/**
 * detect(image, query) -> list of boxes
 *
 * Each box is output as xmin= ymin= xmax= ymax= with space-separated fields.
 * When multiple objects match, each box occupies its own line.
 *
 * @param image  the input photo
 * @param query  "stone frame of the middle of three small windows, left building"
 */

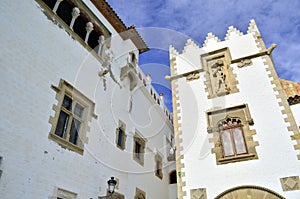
xmin=133 ymin=131 xmax=146 ymax=166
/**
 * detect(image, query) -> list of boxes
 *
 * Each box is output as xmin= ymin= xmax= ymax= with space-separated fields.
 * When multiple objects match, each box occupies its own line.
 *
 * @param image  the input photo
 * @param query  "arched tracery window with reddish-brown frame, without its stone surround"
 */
xmin=219 ymin=118 xmax=247 ymax=157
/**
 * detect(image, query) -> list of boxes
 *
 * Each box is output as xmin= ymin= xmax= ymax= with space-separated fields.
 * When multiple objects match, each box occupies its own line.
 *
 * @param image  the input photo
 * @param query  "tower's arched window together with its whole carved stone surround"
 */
xmin=207 ymin=104 xmax=258 ymax=165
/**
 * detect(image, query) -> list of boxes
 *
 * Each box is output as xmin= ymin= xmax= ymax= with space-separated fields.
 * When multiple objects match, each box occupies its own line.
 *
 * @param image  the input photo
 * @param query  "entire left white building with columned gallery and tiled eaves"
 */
xmin=0 ymin=0 xmax=177 ymax=199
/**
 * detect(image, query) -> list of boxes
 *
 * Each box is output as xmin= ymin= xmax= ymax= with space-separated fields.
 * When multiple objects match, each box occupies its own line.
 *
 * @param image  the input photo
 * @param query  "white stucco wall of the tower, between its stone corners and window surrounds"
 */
xmin=171 ymin=27 xmax=300 ymax=199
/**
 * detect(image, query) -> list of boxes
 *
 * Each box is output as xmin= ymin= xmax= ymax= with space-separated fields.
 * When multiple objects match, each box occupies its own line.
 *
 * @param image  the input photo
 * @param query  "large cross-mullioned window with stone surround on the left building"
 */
xmin=49 ymin=80 xmax=96 ymax=154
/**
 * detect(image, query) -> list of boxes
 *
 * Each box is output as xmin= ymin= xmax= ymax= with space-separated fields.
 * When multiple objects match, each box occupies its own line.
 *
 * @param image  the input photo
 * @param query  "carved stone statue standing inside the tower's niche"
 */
xmin=211 ymin=59 xmax=230 ymax=96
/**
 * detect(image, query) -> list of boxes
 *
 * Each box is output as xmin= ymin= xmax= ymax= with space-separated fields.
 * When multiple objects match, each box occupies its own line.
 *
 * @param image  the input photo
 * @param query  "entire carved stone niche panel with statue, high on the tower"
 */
xmin=201 ymin=48 xmax=239 ymax=99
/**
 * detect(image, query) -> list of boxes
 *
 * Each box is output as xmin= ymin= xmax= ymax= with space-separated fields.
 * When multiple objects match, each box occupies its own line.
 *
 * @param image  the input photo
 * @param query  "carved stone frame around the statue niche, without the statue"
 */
xmin=200 ymin=47 xmax=239 ymax=99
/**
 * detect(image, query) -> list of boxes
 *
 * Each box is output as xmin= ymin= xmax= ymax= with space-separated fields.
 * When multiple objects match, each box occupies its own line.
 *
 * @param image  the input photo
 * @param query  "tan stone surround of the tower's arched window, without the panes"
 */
xmin=206 ymin=104 xmax=259 ymax=165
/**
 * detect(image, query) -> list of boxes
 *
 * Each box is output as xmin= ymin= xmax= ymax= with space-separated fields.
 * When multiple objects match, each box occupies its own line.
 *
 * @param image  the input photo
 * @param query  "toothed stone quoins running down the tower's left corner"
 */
xmin=169 ymin=46 xmax=186 ymax=199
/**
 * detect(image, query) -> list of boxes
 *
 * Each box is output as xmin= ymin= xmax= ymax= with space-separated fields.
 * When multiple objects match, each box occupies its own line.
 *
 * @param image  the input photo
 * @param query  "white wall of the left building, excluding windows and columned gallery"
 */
xmin=0 ymin=0 xmax=176 ymax=199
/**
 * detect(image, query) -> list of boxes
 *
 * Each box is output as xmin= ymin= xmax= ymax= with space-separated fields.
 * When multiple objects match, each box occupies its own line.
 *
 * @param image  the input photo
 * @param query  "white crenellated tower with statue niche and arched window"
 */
xmin=167 ymin=20 xmax=300 ymax=199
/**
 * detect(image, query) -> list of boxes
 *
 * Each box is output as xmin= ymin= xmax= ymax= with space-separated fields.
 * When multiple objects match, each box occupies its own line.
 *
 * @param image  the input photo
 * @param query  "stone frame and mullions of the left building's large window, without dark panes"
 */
xmin=48 ymin=79 xmax=97 ymax=155
